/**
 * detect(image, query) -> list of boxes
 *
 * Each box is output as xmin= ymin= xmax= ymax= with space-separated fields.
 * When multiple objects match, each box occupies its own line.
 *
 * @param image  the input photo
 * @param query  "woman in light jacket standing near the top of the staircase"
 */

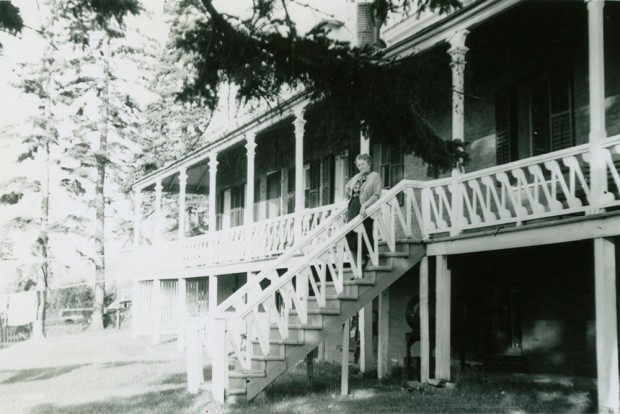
xmin=345 ymin=154 xmax=383 ymax=266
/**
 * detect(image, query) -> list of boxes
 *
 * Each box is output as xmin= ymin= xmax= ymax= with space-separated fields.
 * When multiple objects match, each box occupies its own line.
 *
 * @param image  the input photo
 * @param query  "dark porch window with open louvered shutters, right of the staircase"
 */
xmin=495 ymin=69 xmax=574 ymax=164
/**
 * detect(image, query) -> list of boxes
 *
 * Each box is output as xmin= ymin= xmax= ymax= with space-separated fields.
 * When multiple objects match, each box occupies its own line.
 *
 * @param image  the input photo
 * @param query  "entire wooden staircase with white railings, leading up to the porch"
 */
xmin=209 ymin=182 xmax=425 ymax=403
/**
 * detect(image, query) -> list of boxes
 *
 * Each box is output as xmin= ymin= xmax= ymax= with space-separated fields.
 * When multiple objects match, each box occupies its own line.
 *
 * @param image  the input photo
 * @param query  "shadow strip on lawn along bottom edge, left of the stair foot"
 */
xmin=30 ymin=389 xmax=195 ymax=414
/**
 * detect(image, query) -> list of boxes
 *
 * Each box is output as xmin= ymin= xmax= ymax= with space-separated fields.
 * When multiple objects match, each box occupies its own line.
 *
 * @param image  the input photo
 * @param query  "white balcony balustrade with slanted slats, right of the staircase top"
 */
xmin=422 ymin=133 xmax=620 ymax=236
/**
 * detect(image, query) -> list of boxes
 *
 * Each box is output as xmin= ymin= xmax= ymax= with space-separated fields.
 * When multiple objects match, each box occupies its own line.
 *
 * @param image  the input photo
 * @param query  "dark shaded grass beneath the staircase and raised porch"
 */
xmin=227 ymin=364 xmax=597 ymax=414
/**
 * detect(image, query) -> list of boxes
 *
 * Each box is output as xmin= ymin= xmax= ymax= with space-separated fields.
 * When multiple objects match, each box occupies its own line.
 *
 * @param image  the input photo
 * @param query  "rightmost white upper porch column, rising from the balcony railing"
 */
xmin=586 ymin=0 xmax=607 ymax=214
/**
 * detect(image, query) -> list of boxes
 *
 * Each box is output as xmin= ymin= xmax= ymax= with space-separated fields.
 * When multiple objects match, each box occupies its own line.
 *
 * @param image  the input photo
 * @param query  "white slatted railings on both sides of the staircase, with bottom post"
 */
xmin=211 ymin=181 xmax=425 ymax=402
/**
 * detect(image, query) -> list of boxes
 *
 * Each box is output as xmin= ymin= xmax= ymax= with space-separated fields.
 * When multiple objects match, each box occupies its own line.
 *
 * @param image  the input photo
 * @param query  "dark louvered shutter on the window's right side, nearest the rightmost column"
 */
xmin=549 ymin=71 xmax=573 ymax=151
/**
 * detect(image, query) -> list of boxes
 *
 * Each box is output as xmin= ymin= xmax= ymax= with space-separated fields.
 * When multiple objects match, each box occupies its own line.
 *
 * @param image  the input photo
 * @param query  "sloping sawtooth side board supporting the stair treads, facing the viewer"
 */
xmin=245 ymin=243 xmax=426 ymax=401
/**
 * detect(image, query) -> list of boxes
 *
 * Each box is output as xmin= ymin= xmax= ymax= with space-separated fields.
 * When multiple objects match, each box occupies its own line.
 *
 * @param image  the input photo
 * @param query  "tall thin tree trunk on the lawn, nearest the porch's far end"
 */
xmin=90 ymin=38 xmax=110 ymax=330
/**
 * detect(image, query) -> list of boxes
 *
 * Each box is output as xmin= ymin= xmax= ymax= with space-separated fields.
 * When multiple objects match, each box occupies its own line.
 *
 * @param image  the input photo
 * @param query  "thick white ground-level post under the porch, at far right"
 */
xmin=594 ymin=238 xmax=620 ymax=413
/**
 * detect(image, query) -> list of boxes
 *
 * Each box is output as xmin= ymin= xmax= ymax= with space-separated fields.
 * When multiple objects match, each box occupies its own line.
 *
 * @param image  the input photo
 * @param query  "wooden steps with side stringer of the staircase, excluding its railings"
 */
xmin=226 ymin=241 xmax=425 ymax=401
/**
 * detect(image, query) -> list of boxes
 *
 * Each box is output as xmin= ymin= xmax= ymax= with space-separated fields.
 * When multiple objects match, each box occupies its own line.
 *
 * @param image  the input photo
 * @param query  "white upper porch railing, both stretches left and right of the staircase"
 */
xmin=118 ymin=136 xmax=620 ymax=282
